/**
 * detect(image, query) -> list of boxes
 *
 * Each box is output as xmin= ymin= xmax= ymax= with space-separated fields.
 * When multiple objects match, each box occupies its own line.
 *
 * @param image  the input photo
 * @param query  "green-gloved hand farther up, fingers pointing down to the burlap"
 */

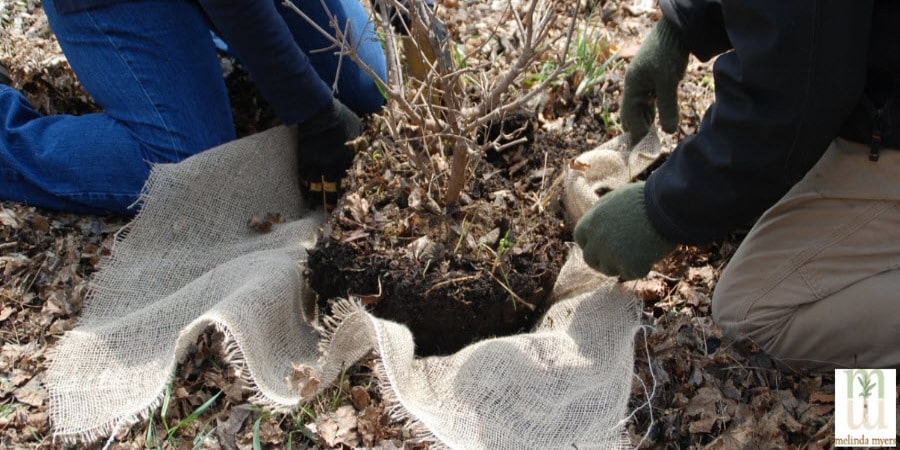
xmin=619 ymin=18 xmax=689 ymax=143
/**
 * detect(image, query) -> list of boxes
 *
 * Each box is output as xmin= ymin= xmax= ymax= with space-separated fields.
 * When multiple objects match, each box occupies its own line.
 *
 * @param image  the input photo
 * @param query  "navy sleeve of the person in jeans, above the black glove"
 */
xmin=200 ymin=0 xmax=332 ymax=124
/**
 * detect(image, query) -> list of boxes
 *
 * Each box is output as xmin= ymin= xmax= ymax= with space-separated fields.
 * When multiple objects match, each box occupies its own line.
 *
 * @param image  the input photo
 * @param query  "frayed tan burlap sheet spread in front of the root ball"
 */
xmin=46 ymin=127 xmax=658 ymax=449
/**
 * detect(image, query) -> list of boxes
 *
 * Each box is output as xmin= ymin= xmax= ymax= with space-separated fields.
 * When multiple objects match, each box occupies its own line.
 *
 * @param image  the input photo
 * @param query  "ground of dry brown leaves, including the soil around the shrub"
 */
xmin=0 ymin=0 xmax=888 ymax=449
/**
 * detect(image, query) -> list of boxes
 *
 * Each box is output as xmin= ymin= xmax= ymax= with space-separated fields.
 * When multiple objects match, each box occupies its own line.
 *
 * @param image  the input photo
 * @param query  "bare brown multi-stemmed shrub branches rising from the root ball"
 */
xmin=284 ymin=0 xmax=576 ymax=206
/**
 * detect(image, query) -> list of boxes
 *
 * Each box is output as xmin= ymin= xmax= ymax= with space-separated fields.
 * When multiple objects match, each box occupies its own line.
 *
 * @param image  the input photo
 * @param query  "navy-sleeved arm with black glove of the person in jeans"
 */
xmin=199 ymin=0 xmax=363 ymax=205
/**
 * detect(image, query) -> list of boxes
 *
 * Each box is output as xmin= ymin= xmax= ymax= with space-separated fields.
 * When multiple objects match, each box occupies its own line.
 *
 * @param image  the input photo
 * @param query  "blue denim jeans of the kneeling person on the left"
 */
xmin=0 ymin=0 xmax=385 ymax=214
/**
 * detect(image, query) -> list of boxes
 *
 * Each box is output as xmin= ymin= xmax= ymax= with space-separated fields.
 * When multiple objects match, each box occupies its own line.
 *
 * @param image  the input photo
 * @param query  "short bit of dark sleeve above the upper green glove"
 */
xmin=659 ymin=0 xmax=731 ymax=61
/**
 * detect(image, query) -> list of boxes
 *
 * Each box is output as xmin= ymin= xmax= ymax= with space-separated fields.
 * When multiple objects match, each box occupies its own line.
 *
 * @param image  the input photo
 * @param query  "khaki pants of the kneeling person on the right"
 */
xmin=712 ymin=139 xmax=900 ymax=369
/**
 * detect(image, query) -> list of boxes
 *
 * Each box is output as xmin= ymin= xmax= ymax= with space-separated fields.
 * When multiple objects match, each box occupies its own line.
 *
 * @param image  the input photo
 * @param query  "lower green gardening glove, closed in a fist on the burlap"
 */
xmin=575 ymin=182 xmax=676 ymax=280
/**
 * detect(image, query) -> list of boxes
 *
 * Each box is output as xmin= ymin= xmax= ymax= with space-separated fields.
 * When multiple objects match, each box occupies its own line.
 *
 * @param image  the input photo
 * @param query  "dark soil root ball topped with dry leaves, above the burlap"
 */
xmin=308 ymin=96 xmax=616 ymax=356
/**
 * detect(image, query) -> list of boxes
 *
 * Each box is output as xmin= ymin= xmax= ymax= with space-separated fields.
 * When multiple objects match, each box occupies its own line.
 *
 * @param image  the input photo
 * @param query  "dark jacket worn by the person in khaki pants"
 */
xmin=644 ymin=0 xmax=900 ymax=244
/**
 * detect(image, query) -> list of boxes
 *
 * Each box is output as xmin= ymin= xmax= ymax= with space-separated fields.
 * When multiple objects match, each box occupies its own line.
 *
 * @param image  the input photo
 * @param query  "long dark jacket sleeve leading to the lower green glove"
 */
xmin=644 ymin=0 xmax=872 ymax=245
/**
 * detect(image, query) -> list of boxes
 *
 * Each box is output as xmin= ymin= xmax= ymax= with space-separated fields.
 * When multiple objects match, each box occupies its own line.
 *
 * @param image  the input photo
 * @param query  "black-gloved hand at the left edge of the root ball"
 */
xmin=297 ymin=99 xmax=363 ymax=205
